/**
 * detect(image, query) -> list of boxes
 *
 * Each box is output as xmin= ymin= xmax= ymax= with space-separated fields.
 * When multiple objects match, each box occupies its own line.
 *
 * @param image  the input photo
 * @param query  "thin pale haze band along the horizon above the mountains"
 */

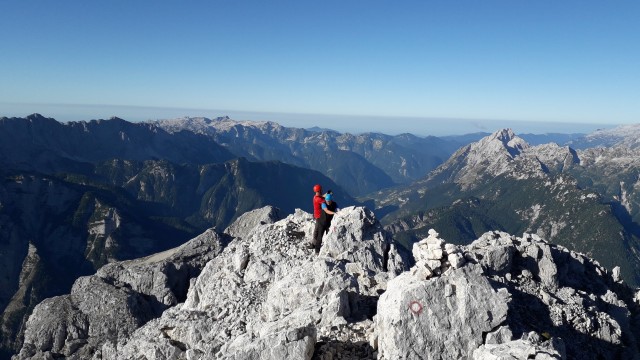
xmin=0 ymin=103 xmax=624 ymax=136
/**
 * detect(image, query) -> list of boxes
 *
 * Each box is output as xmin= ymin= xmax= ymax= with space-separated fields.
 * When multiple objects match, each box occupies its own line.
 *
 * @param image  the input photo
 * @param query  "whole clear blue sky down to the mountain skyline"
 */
xmin=0 ymin=0 xmax=640 ymax=134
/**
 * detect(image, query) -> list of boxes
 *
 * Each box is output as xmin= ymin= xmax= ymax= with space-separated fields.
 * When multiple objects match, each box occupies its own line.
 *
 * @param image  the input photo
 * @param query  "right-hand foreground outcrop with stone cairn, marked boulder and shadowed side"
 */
xmin=375 ymin=231 xmax=640 ymax=360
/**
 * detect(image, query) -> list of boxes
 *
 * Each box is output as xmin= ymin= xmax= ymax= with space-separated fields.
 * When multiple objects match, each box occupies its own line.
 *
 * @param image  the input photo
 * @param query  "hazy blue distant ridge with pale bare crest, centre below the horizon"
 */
xmin=153 ymin=117 xmax=459 ymax=196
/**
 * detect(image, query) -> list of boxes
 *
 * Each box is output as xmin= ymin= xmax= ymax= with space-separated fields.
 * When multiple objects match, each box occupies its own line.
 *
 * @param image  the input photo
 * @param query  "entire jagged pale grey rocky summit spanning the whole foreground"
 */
xmin=14 ymin=207 xmax=640 ymax=360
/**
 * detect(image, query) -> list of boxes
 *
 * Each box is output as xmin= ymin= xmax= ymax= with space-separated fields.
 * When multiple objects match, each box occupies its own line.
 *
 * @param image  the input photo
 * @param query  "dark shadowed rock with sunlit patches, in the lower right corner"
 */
xmin=491 ymin=240 xmax=638 ymax=360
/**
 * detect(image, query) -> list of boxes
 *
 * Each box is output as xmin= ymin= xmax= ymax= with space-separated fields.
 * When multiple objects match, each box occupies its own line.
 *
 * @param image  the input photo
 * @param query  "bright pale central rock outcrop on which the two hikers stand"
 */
xmin=97 ymin=208 xmax=402 ymax=359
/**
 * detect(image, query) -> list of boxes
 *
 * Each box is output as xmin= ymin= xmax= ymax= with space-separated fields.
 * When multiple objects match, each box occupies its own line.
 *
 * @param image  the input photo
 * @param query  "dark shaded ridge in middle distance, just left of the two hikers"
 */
xmin=96 ymin=158 xmax=357 ymax=229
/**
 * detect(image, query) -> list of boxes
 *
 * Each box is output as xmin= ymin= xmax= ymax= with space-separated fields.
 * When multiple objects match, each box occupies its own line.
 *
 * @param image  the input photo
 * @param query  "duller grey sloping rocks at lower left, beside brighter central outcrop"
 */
xmin=16 ymin=230 xmax=228 ymax=359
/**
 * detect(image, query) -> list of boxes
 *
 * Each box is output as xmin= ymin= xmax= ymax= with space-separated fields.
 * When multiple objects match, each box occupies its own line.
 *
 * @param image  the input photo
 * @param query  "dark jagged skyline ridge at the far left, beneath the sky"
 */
xmin=0 ymin=114 xmax=235 ymax=173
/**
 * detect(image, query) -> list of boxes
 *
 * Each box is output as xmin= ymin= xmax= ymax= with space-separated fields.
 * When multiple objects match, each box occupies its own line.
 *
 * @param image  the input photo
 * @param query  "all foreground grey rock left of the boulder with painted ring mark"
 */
xmin=17 ymin=207 xmax=406 ymax=359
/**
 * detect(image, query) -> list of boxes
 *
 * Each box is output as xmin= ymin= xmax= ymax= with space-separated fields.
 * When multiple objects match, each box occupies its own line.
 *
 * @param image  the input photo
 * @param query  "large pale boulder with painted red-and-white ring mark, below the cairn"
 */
xmin=376 ymin=265 xmax=508 ymax=359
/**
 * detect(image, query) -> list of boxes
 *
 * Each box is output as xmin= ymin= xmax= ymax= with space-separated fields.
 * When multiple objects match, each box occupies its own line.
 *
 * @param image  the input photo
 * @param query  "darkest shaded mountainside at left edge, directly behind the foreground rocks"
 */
xmin=0 ymin=172 xmax=192 ymax=358
